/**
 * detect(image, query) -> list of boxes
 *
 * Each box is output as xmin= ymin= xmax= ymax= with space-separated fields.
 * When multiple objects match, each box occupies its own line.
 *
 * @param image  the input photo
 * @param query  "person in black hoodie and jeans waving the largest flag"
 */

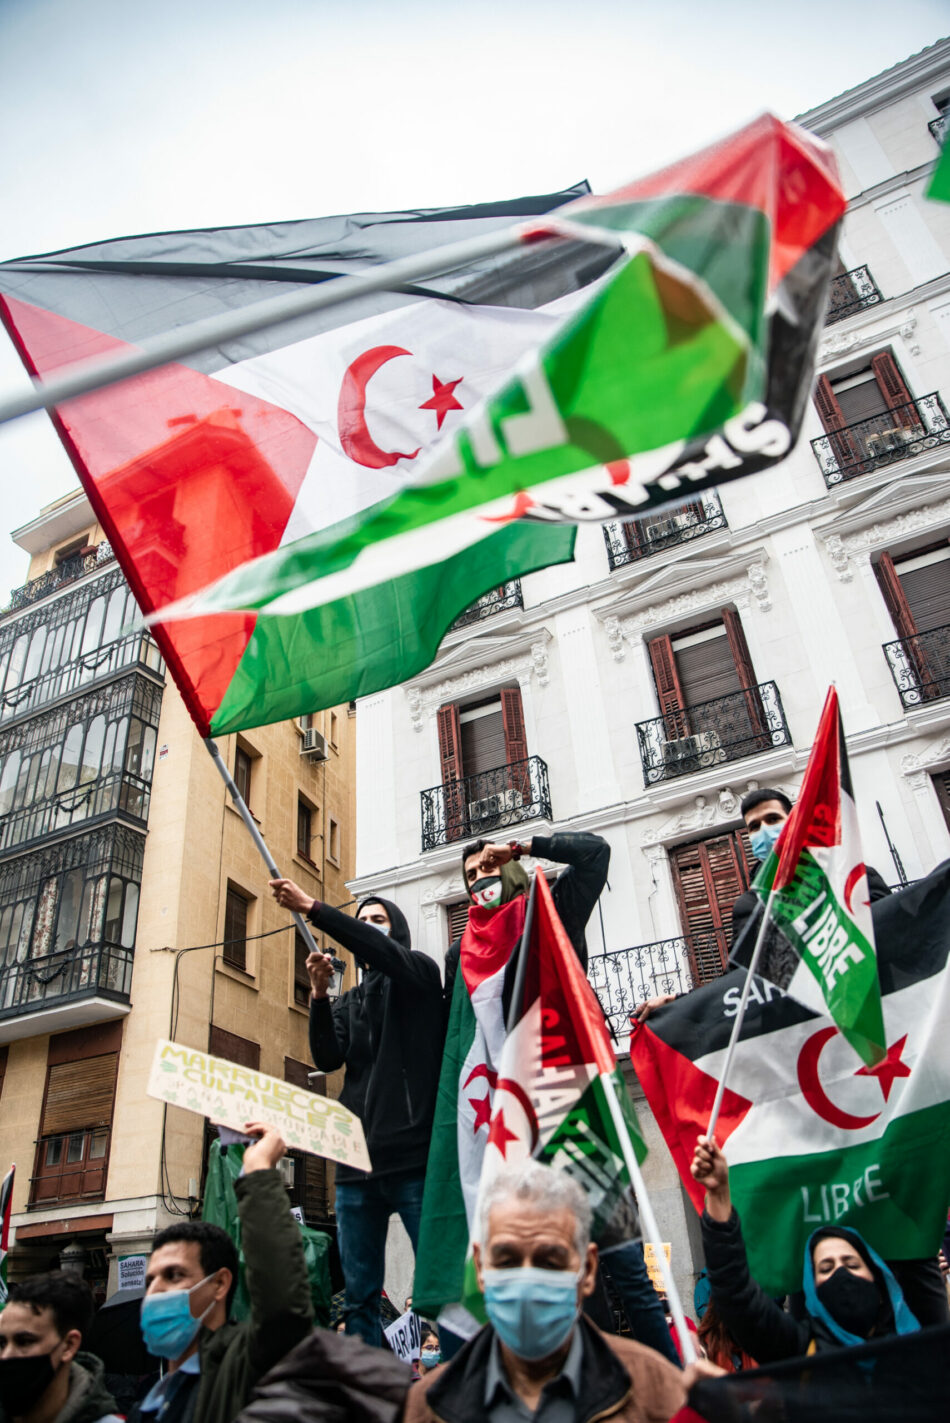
xmin=270 ymin=879 xmax=444 ymax=1346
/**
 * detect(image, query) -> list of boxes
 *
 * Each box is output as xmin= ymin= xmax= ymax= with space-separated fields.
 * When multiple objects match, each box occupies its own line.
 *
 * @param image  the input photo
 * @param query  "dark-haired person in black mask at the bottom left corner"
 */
xmin=0 ymin=1271 xmax=119 ymax=1423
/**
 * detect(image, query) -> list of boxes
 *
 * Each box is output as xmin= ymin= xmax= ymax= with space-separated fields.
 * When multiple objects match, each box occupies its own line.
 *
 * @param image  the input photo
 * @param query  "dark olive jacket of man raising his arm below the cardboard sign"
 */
xmin=193 ymin=1171 xmax=313 ymax=1423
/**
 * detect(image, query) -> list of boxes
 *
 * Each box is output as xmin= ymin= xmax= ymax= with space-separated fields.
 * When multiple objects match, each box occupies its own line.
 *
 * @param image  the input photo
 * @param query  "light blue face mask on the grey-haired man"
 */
xmin=482 ymin=1265 xmax=583 ymax=1359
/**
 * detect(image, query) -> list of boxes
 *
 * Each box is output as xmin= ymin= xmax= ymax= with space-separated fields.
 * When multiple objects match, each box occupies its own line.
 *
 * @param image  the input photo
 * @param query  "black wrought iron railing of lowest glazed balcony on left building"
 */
xmin=0 ymin=943 xmax=132 ymax=1022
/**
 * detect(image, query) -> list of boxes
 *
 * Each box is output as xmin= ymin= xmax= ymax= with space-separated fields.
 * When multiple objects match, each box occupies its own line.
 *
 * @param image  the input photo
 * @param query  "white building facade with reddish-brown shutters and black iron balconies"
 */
xmin=351 ymin=41 xmax=950 ymax=1301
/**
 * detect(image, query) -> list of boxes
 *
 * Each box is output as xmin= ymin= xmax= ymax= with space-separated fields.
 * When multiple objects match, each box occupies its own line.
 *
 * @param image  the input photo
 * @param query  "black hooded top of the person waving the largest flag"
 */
xmin=309 ymin=899 xmax=445 ymax=1181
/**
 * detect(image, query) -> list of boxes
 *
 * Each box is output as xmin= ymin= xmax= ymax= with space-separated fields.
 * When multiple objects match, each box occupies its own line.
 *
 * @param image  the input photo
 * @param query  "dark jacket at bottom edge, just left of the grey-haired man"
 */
xmin=240 ymin=1329 xmax=412 ymax=1423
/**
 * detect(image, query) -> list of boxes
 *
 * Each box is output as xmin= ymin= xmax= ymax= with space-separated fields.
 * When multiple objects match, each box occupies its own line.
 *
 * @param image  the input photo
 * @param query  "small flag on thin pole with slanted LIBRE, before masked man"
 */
xmin=732 ymin=687 xmax=886 ymax=1066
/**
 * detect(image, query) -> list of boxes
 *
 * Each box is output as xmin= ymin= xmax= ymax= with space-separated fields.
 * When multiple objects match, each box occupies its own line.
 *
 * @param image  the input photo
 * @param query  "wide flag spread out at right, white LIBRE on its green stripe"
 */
xmin=630 ymin=861 xmax=950 ymax=1295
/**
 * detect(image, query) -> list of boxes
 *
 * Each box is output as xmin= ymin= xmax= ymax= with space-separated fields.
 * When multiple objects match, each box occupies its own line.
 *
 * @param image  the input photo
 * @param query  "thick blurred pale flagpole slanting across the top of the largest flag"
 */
xmin=0 ymin=218 xmax=604 ymax=424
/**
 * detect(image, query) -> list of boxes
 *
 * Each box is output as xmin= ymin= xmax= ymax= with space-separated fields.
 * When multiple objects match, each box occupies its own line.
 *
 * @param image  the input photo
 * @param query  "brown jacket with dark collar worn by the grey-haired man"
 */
xmin=405 ymin=1315 xmax=685 ymax=1423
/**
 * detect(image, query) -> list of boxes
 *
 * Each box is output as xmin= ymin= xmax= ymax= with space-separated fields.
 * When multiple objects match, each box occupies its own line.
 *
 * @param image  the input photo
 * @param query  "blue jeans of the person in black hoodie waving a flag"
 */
xmin=337 ymin=1175 xmax=425 ymax=1349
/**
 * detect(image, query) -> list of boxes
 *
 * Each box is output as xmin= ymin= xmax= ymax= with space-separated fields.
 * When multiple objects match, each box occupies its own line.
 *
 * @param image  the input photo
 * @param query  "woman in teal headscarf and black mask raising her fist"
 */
xmin=691 ymin=1137 xmax=920 ymax=1363
